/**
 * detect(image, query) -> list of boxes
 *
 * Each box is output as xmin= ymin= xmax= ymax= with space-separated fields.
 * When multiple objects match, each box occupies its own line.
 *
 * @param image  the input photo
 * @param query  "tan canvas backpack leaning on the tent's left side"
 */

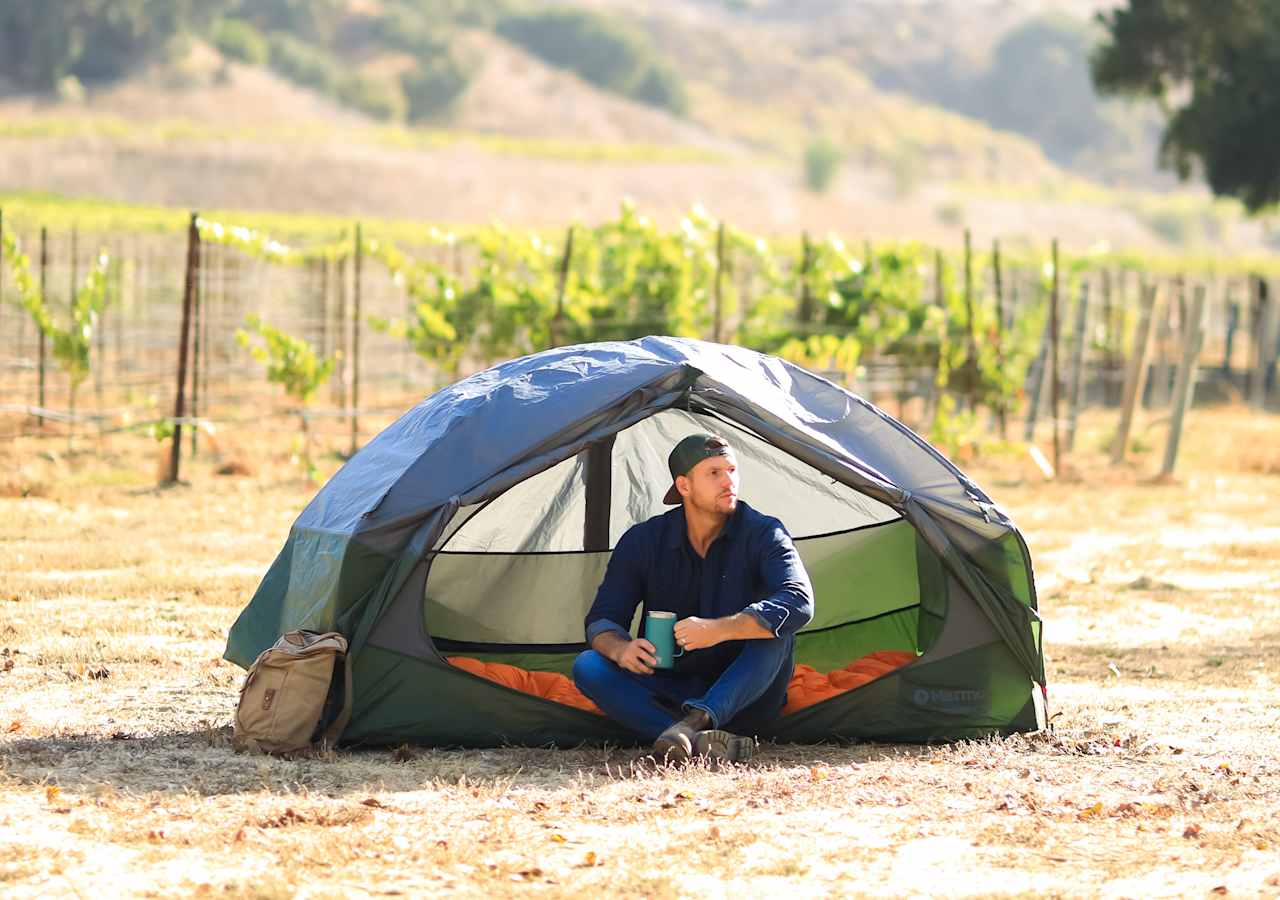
xmin=234 ymin=631 xmax=351 ymax=754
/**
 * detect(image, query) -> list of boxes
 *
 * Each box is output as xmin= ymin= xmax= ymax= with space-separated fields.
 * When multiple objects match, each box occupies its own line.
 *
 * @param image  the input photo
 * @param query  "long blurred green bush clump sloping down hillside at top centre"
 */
xmin=497 ymin=6 xmax=687 ymax=114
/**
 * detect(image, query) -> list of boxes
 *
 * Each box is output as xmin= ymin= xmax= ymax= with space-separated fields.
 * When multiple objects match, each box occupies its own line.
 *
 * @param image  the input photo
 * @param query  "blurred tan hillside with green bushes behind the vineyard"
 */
xmin=0 ymin=0 xmax=1267 ymax=250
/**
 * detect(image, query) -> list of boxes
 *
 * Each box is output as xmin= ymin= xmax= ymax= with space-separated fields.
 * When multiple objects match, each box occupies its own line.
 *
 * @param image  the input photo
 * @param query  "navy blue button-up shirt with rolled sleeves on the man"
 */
xmin=585 ymin=501 xmax=813 ymax=679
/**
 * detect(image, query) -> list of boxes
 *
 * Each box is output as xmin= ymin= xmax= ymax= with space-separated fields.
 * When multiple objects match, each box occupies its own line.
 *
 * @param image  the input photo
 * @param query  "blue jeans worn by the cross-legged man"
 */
xmin=573 ymin=636 xmax=795 ymax=741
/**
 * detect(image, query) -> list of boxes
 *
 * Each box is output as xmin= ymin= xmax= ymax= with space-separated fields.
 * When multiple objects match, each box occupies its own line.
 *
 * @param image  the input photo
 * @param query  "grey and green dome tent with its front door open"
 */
xmin=225 ymin=337 xmax=1044 ymax=746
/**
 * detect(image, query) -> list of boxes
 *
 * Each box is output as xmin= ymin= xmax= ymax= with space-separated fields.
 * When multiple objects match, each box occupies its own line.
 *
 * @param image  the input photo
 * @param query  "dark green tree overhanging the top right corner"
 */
xmin=1093 ymin=0 xmax=1280 ymax=213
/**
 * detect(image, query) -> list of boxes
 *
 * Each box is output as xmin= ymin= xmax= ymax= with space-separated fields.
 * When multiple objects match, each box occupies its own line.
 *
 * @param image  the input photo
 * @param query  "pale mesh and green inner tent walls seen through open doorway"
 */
xmin=422 ymin=410 xmax=946 ymax=673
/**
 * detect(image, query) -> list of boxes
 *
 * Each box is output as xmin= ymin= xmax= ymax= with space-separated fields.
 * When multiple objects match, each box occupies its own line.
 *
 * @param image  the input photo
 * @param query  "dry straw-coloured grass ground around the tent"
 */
xmin=0 ymin=411 xmax=1280 ymax=897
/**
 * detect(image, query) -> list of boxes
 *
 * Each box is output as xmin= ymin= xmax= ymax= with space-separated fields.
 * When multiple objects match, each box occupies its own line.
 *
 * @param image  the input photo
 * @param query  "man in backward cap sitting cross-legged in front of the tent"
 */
xmin=573 ymin=434 xmax=813 ymax=762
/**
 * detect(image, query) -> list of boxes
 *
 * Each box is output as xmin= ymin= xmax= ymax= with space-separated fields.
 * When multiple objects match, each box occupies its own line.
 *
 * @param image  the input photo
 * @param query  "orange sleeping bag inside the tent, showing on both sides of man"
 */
xmin=447 ymin=650 xmax=915 ymax=716
